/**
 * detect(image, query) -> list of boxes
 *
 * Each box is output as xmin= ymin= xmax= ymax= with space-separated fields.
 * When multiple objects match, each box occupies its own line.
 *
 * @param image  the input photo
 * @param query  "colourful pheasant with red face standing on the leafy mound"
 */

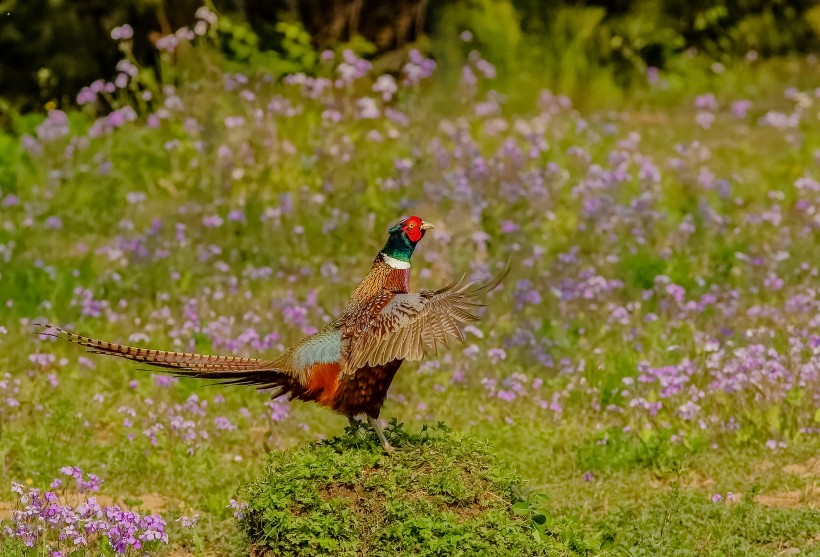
xmin=41 ymin=216 xmax=509 ymax=452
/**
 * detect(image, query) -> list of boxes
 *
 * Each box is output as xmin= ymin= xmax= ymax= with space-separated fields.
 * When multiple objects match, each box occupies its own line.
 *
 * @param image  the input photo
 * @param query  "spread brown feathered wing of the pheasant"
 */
xmin=342 ymin=265 xmax=510 ymax=373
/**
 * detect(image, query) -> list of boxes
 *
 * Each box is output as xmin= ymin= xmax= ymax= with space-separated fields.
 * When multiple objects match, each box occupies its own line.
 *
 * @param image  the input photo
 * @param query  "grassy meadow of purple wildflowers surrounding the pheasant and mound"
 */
xmin=0 ymin=7 xmax=820 ymax=557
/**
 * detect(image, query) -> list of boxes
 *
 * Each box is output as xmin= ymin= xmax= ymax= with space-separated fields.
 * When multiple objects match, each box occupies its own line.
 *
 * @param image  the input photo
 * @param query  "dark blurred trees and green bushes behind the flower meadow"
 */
xmin=0 ymin=0 xmax=820 ymax=113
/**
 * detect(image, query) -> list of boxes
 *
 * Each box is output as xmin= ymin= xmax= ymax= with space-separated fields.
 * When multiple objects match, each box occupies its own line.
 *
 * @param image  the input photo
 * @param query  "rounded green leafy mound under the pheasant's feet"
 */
xmin=242 ymin=423 xmax=558 ymax=557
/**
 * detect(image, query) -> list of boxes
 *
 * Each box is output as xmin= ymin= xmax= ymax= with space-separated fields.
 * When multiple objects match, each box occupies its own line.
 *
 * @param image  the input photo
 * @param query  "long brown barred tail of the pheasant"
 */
xmin=35 ymin=323 xmax=293 ymax=389
